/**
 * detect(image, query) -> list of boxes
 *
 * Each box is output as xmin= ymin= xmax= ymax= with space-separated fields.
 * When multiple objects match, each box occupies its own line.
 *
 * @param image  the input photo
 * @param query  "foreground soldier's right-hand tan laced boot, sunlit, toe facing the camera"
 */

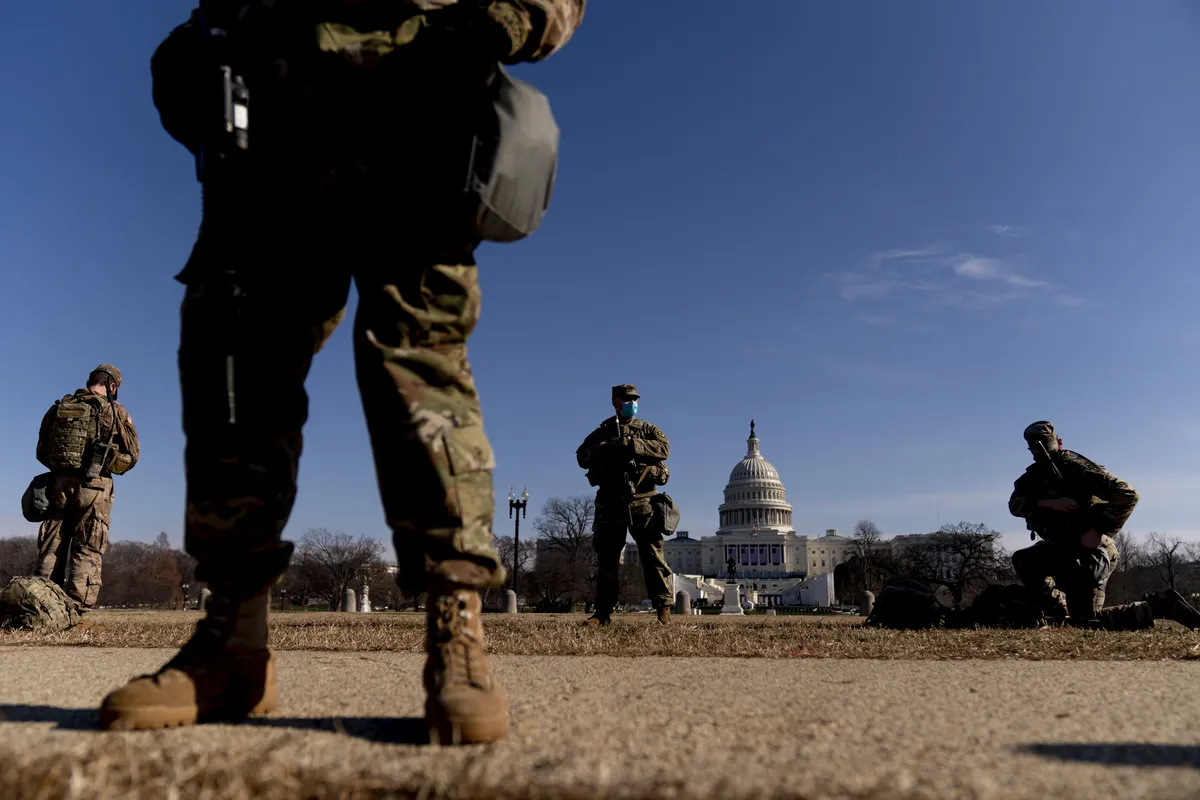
xmin=424 ymin=585 xmax=509 ymax=745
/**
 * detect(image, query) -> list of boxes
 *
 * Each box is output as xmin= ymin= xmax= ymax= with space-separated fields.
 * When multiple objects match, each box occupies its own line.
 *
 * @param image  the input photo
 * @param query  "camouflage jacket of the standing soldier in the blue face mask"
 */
xmin=575 ymin=416 xmax=671 ymax=498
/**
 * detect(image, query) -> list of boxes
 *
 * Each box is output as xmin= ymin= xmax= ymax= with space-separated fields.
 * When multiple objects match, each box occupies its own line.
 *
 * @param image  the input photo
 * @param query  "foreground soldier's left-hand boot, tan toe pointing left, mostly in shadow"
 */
xmin=100 ymin=587 xmax=278 ymax=730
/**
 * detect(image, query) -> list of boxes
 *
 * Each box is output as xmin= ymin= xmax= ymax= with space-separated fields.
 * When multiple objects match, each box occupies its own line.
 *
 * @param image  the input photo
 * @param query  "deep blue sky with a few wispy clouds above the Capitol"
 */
xmin=0 ymin=0 xmax=1200 ymax=561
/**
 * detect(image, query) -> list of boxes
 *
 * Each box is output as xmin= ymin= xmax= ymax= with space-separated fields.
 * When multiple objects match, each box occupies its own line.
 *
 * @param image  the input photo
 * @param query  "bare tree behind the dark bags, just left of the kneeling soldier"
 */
xmin=900 ymin=522 xmax=1013 ymax=608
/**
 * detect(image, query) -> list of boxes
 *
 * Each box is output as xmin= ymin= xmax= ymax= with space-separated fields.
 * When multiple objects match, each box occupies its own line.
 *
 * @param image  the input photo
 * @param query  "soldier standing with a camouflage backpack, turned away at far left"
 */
xmin=35 ymin=363 xmax=142 ymax=614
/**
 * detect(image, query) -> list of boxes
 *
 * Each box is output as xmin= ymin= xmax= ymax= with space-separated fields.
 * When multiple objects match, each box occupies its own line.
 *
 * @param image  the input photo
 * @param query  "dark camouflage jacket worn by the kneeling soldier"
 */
xmin=1008 ymin=450 xmax=1138 ymax=551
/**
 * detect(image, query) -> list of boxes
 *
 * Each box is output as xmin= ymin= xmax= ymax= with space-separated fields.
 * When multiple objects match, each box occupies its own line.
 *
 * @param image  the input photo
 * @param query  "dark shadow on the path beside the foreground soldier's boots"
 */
xmin=0 ymin=704 xmax=430 ymax=745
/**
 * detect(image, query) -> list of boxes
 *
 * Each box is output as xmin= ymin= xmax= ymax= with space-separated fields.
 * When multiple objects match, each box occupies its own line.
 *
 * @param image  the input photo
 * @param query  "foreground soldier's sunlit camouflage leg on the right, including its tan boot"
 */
xmin=354 ymin=256 xmax=509 ymax=744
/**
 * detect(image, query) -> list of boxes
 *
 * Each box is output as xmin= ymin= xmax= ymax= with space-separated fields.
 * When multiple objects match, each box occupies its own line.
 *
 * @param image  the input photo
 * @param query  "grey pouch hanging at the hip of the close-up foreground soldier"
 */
xmin=463 ymin=67 xmax=559 ymax=242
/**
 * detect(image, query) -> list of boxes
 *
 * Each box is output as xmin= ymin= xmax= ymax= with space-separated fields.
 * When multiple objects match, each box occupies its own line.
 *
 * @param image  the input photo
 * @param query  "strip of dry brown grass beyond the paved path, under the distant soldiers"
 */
xmin=0 ymin=612 xmax=1200 ymax=661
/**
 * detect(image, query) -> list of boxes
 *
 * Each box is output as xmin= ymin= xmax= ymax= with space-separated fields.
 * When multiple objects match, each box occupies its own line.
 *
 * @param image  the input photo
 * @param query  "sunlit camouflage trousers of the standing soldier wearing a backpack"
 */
xmin=34 ymin=475 xmax=113 ymax=612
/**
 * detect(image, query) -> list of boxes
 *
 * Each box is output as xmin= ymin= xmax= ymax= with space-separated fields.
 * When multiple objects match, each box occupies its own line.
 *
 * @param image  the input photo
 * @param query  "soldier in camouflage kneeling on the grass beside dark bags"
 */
xmin=1008 ymin=420 xmax=1200 ymax=630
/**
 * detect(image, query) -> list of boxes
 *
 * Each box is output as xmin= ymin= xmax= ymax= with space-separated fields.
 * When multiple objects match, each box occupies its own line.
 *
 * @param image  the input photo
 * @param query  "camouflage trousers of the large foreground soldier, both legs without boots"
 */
xmin=179 ymin=206 xmax=505 ymax=593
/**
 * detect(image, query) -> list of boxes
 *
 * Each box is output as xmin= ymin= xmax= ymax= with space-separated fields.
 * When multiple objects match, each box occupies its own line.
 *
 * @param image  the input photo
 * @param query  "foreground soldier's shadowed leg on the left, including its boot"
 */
xmin=101 ymin=250 xmax=349 ymax=729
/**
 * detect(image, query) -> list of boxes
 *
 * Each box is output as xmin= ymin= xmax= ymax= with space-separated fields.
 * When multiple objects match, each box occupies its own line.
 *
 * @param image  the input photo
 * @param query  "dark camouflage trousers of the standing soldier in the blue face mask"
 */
xmin=592 ymin=495 xmax=673 ymax=614
